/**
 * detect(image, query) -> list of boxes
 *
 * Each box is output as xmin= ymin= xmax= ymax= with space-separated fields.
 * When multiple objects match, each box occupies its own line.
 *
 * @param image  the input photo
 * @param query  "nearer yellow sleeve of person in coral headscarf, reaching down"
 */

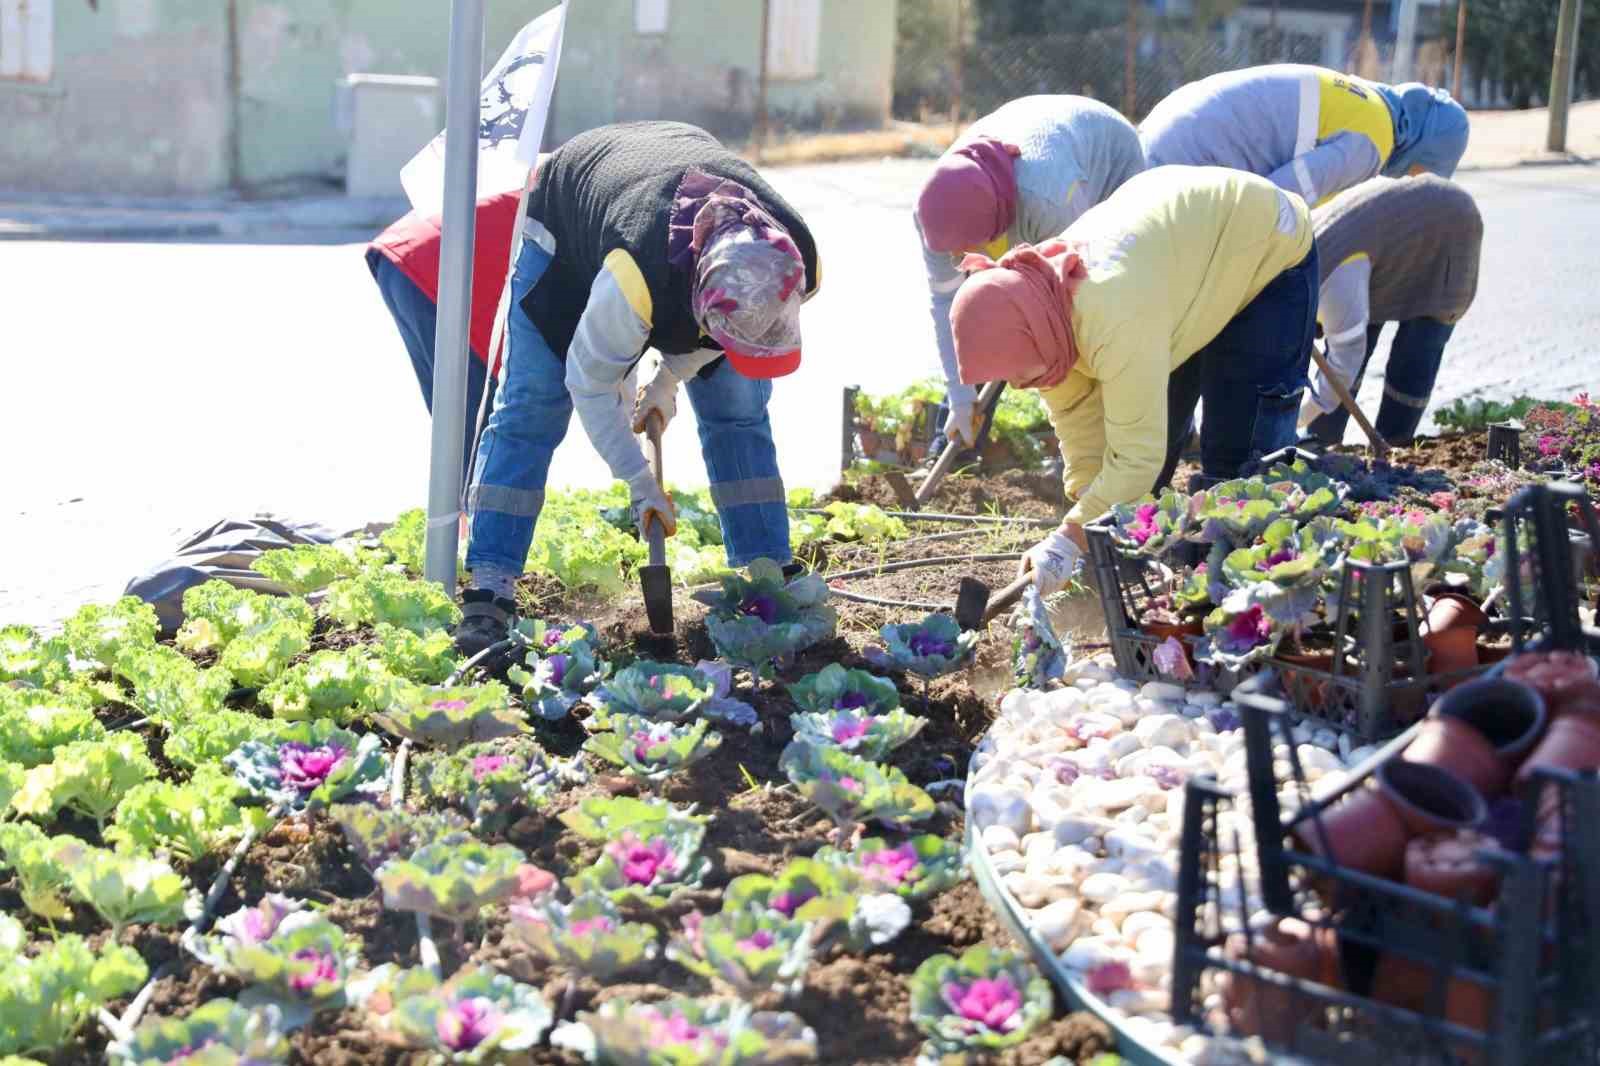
xmin=1067 ymin=319 xmax=1171 ymax=522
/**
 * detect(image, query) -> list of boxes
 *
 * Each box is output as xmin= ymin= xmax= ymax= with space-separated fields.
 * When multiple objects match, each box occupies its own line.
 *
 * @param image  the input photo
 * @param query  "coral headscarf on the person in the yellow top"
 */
xmin=950 ymin=240 xmax=1088 ymax=389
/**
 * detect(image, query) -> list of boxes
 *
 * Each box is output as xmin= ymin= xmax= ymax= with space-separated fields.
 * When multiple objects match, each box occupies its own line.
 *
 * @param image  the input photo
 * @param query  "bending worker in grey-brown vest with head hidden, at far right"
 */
xmin=1299 ymin=174 xmax=1483 ymax=443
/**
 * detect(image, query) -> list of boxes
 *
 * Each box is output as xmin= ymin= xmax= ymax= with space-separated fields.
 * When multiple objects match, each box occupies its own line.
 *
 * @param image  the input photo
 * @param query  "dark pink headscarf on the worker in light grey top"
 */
xmin=917 ymin=136 xmax=1022 ymax=251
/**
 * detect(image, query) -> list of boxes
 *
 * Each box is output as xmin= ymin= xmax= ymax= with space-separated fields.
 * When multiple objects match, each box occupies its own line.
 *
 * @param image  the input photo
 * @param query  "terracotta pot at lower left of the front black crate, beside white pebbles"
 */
xmin=1222 ymin=919 xmax=1344 ymax=1044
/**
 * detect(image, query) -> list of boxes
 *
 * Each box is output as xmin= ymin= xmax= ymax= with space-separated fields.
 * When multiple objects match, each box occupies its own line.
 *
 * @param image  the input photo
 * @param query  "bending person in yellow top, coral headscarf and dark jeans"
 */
xmin=950 ymin=166 xmax=1317 ymax=594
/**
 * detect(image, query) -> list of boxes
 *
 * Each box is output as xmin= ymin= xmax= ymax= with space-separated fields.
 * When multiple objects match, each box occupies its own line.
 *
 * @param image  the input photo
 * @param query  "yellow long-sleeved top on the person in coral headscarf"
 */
xmin=1043 ymin=166 xmax=1312 ymax=522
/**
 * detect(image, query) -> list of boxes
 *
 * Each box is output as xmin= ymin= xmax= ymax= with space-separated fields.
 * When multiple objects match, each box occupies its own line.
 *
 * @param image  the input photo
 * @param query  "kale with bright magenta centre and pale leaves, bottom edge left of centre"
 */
xmin=386 ymin=967 xmax=550 ymax=1063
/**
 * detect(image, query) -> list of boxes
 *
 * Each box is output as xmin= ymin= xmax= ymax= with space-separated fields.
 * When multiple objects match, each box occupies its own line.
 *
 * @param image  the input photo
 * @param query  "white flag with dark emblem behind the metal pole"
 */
xmin=400 ymin=0 xmax=566 ymax=214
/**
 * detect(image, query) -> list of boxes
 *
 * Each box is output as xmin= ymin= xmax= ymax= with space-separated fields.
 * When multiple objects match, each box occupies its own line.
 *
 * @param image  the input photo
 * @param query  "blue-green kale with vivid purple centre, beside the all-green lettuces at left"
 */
xmin=222 ymin=722 xmax=389 ymax=813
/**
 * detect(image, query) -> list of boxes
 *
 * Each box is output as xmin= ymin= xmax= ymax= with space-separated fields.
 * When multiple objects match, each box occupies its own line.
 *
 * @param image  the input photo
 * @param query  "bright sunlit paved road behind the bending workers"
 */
xmin=0 ymin=160 xmax=1600 ymax=623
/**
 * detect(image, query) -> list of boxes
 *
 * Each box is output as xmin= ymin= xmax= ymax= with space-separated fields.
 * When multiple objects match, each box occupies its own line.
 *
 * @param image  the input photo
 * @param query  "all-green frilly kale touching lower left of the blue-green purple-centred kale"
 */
xmin=104 ymin=765 xmax=270 ymax=863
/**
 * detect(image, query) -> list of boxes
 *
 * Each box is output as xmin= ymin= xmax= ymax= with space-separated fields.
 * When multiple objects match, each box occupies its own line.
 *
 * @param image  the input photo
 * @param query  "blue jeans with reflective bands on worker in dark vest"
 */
xmin=467 ymin=240 xmax=790 ymax=575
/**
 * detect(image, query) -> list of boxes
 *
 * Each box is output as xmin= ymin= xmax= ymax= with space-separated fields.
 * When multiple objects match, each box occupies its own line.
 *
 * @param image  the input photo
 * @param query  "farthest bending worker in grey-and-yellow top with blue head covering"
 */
xmin=1139 ymin=62 xmax=1467 ymax=205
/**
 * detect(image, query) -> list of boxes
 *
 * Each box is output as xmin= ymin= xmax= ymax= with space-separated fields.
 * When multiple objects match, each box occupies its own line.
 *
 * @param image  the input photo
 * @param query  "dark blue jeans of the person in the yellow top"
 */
xmin=1155 ymin=245 xmax=1317 ymax=488
